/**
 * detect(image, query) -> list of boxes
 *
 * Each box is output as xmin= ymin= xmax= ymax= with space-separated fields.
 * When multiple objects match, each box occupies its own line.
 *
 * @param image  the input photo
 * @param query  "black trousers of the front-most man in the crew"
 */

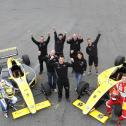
xmin=57 ymin=78 xmax=70 ymax=99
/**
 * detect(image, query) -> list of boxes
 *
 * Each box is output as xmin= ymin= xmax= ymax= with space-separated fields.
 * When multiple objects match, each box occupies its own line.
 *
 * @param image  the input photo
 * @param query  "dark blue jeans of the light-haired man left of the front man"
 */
xmin=47 ymin=72 xmax=57 ymax=89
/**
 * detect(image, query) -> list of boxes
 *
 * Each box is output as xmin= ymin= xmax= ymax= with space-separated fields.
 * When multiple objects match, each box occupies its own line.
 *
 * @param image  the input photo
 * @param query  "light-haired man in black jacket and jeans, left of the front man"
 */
xmin=45 ymin=50 xmax=58 ymax=92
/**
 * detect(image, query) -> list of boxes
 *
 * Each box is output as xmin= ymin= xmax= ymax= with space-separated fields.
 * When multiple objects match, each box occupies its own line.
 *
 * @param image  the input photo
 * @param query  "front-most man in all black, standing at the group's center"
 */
xmin=54 ymin=56 xmax=72 ymax=102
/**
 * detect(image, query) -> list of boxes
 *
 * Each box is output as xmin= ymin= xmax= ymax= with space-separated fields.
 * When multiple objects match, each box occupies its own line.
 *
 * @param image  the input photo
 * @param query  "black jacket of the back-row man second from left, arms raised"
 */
xmin=54 ymin=32 xmax=66 ymax=53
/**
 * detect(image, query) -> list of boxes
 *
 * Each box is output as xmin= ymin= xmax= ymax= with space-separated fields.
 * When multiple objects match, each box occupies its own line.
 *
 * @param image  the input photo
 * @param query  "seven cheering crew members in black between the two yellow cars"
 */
xmin=31 ymin=28 xmax=101 ymax=101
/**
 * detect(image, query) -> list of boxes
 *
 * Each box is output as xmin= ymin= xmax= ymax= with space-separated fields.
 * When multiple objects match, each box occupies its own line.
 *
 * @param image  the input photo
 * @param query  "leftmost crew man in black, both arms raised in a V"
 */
xmin=31 ymin=33 xmax=50 ymax=74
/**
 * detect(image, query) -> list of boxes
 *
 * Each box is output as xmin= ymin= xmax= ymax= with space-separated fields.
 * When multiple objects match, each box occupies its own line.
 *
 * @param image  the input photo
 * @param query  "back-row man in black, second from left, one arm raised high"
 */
xmin=53 ymin=28 xmax=66 ymax=57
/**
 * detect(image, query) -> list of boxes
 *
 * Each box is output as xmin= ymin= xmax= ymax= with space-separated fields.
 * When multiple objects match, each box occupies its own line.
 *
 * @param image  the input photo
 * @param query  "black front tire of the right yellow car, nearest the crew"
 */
xmin=77 ymin=81 xmax=89 ymax=96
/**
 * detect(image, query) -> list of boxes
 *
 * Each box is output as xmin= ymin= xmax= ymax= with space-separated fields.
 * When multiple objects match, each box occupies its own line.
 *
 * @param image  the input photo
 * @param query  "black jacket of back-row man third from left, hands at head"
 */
xmin=67 ymin=38 xmax=83 ymax=52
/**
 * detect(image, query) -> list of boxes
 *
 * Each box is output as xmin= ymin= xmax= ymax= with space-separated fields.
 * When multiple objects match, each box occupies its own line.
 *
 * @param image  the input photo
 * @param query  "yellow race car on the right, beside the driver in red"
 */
xmin=72 ymin=56 xmax=126 ymax=124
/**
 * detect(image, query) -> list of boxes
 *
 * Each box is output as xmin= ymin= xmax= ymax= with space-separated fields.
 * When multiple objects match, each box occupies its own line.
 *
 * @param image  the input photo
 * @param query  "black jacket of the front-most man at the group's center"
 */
xmin=54 ymin=62 xmax=72 ymax=81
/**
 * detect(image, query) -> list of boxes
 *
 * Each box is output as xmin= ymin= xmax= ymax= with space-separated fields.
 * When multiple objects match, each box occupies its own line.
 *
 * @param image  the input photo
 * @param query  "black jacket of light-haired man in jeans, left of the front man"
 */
xmin=45 ymin=55 xmax=58 ymax=72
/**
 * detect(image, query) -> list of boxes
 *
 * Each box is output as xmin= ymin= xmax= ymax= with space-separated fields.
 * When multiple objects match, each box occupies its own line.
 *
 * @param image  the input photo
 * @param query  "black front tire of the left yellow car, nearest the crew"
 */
xmin=41 ymin=83 xmax=51 ymax=96
